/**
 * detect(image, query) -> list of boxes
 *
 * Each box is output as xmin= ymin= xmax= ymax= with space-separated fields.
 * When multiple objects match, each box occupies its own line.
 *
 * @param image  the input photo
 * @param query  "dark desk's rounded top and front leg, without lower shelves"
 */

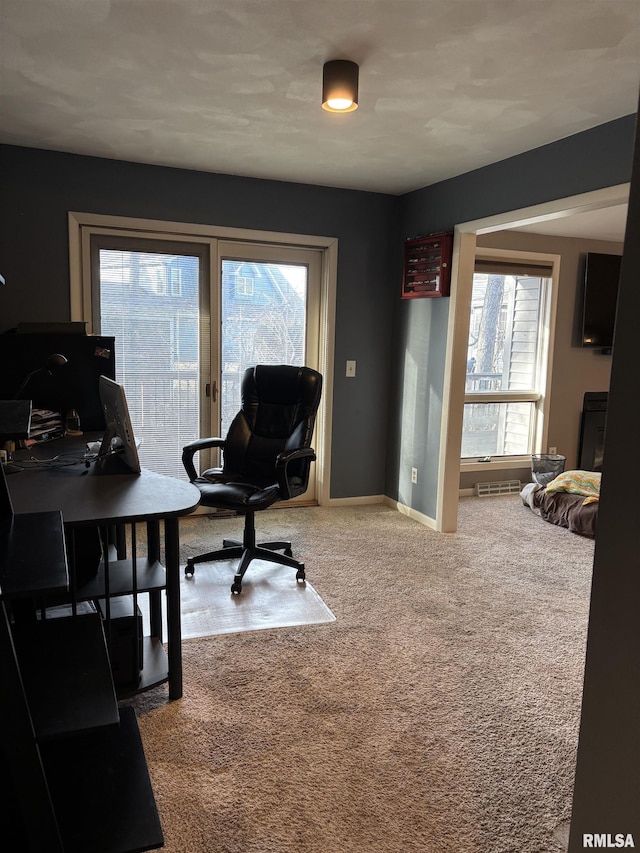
xmin=7 ymin=435 xmax=200 ymax=699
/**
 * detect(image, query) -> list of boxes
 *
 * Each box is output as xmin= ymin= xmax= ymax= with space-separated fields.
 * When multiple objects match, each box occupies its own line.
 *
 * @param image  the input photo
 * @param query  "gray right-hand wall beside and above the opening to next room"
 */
xmin=385 ymin=116 xmax=635 ymax=518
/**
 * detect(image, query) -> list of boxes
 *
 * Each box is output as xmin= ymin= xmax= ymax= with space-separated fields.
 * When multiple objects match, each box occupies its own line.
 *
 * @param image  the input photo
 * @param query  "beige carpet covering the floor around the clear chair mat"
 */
xmin=133 ymin=495 xmax=593 ymax=853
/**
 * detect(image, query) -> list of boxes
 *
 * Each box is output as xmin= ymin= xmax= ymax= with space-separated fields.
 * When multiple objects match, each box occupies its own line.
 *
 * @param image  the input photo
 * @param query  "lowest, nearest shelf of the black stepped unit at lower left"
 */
xmin=41 ymin=708 xmax=164 ymax=853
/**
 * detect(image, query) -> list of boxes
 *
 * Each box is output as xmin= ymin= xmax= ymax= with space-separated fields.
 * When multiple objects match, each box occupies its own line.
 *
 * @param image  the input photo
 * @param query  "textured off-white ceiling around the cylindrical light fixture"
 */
xmin=0 ymin=0 xmax=640 ymax=201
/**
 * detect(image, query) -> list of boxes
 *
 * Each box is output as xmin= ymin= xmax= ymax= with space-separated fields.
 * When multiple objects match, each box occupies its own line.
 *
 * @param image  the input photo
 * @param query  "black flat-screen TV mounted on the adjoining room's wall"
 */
xmin=582 ymin=252 xmax=622 ymax=350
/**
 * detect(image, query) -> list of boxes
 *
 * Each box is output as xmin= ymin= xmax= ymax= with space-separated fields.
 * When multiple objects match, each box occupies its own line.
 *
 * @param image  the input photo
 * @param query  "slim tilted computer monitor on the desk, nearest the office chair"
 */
xmin=98 ymin=376 xmax=140 ymax=474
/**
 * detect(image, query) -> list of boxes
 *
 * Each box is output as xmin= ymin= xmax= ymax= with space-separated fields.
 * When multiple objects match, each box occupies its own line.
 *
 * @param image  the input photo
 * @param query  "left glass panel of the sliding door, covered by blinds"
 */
xmin=94 ymin=238 xmax=209 ymax=479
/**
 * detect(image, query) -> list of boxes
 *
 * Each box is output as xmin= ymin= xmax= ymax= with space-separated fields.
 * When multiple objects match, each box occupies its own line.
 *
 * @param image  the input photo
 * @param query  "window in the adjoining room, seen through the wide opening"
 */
xmin=461 ymin=257 xmax=553 ymax=462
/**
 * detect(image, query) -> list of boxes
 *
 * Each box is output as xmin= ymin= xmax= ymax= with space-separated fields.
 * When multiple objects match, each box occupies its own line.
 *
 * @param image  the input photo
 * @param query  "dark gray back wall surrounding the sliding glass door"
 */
xmin=0 ymin=145 xmax=399 ymax=497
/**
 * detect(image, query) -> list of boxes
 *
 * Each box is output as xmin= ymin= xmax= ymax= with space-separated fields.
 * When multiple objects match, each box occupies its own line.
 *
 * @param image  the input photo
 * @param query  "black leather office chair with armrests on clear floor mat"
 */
xmin=182 ymin=364 xmax=322 ymax=594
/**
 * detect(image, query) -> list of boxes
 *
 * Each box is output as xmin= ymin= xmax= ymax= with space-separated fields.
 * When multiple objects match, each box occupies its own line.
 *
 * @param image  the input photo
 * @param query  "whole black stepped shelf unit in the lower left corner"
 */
xmin=0 ymin=502 xmax=164 ymax=853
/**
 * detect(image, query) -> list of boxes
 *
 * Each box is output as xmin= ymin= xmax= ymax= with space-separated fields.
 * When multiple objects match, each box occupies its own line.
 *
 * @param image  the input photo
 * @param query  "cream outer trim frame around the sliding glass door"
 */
xmin=68 ymin=211 xmax=338 ymax=506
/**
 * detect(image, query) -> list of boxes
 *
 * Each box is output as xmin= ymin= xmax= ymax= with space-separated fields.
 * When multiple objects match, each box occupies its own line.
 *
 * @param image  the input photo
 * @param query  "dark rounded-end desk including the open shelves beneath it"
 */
xmin=7 ymin=433 xmax=200 ymax=699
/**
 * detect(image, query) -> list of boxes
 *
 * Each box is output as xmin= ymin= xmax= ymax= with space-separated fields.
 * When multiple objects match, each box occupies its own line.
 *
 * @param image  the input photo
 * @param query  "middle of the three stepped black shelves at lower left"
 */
xmin=13 ymin=613 xmax=119 ymax=742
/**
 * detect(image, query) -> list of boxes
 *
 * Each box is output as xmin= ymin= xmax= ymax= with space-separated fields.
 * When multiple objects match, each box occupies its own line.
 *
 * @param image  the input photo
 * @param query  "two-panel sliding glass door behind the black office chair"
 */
xmin=91 ymin=233 xmax=322 ymax=500
